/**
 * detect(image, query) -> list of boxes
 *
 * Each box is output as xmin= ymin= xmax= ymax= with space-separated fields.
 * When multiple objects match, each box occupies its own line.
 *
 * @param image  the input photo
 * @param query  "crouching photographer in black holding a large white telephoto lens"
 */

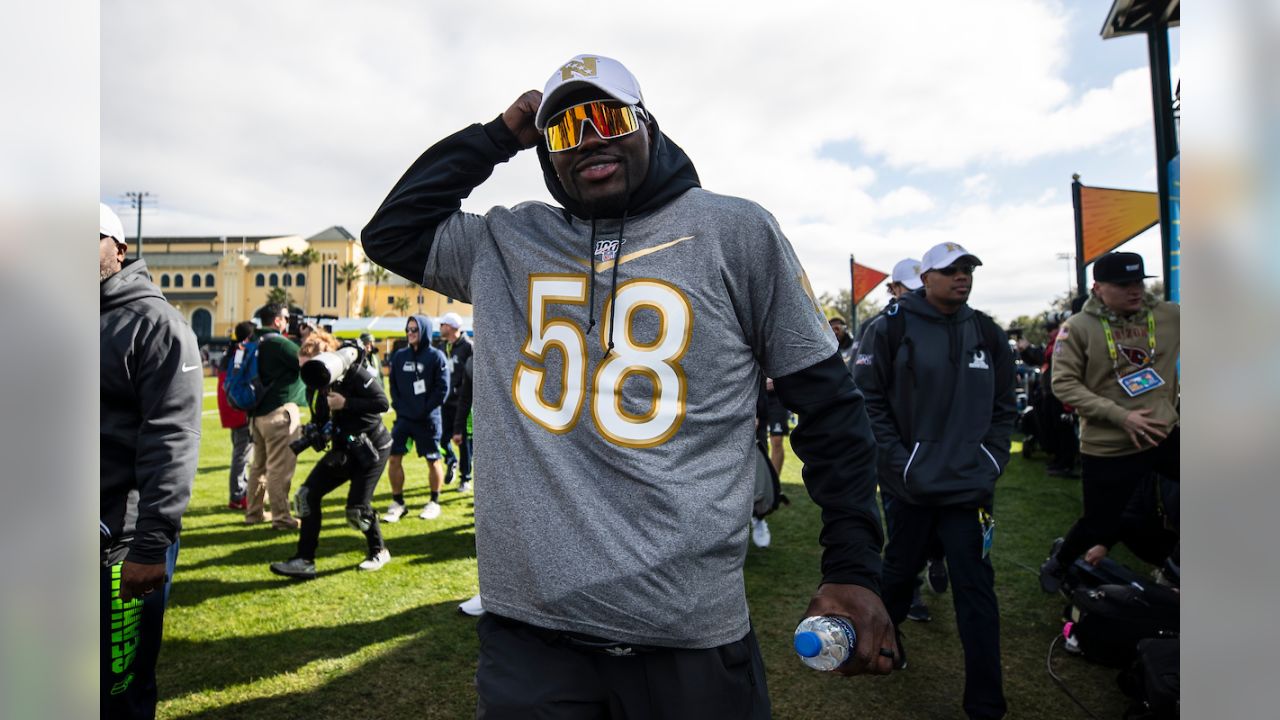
xmin=271 ymin=329 xmax=392 ymax=579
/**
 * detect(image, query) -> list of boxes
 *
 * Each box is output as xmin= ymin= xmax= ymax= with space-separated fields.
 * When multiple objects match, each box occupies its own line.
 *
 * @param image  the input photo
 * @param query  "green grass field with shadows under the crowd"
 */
xmin=159 ymin=379 xmax=1142 ymax=720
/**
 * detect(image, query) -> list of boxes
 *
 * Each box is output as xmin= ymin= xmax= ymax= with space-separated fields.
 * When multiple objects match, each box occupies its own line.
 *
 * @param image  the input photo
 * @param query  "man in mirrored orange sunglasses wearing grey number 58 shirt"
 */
xmin=361 ymin=55 xmax=895 ymax=717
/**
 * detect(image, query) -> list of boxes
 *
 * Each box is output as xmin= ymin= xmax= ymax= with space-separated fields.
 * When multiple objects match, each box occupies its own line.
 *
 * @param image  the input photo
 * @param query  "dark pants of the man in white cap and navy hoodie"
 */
xmin=882 ymin=501 xmax=1006 ymax=717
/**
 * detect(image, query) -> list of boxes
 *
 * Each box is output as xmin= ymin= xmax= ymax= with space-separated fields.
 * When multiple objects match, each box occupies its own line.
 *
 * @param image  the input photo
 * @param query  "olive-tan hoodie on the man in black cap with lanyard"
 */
xmin=1053 ymin=293 xmax=1181 ymax=457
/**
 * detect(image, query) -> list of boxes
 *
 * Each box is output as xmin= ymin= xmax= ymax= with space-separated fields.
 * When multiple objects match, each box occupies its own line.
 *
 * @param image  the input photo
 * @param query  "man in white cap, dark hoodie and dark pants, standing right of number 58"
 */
xmin=854 ymin=242 xmax=1016 ymax=717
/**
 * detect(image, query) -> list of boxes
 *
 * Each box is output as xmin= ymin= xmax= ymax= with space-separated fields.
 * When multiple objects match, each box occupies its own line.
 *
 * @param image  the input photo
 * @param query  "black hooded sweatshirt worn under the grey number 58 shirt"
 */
xmin=361 ymin=113 xmax=883 ymax=592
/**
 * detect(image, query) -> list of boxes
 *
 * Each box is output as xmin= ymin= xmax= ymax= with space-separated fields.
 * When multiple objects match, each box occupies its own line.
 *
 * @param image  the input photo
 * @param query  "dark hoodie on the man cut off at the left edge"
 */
xmin=99 ymin=260 xmax=204 ymax=564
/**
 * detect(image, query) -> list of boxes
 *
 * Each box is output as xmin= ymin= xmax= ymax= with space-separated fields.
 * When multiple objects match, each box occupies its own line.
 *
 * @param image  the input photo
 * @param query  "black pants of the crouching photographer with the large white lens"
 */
xmin=294 ymin=438 xmax=390 ymax=561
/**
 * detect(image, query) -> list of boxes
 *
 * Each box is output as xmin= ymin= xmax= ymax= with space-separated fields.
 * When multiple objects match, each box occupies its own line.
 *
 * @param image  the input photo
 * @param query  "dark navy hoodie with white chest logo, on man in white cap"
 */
xmin=854 ymin=291 xmax=1016 ymax=506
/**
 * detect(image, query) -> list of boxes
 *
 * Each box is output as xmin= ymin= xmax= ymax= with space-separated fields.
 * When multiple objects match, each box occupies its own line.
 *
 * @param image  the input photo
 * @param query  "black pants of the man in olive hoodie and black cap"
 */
xmin=1057 ymin=428 xmax=1179 ymax=566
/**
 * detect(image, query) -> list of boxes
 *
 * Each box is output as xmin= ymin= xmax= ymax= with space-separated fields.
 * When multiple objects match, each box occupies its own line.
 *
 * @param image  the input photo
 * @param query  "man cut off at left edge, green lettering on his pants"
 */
xmin=99 ymin=205 xmax=204 ymax=719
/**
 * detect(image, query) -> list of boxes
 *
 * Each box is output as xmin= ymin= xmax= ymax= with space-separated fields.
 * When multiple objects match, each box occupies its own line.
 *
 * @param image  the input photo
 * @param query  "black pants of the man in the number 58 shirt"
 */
xmin=476 ymin=612 xmax=771 ymax=720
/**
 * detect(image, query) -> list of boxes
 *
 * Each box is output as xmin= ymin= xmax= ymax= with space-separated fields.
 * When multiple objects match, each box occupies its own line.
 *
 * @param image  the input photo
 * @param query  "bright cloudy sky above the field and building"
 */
xmin=100 ymin=0 xmax=1179 ymax=322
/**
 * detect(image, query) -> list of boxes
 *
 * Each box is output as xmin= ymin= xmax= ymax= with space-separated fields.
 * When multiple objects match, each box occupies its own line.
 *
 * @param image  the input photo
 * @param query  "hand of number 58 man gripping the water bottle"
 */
xmin=805 ymin=583 xmax=897 ymax=675
